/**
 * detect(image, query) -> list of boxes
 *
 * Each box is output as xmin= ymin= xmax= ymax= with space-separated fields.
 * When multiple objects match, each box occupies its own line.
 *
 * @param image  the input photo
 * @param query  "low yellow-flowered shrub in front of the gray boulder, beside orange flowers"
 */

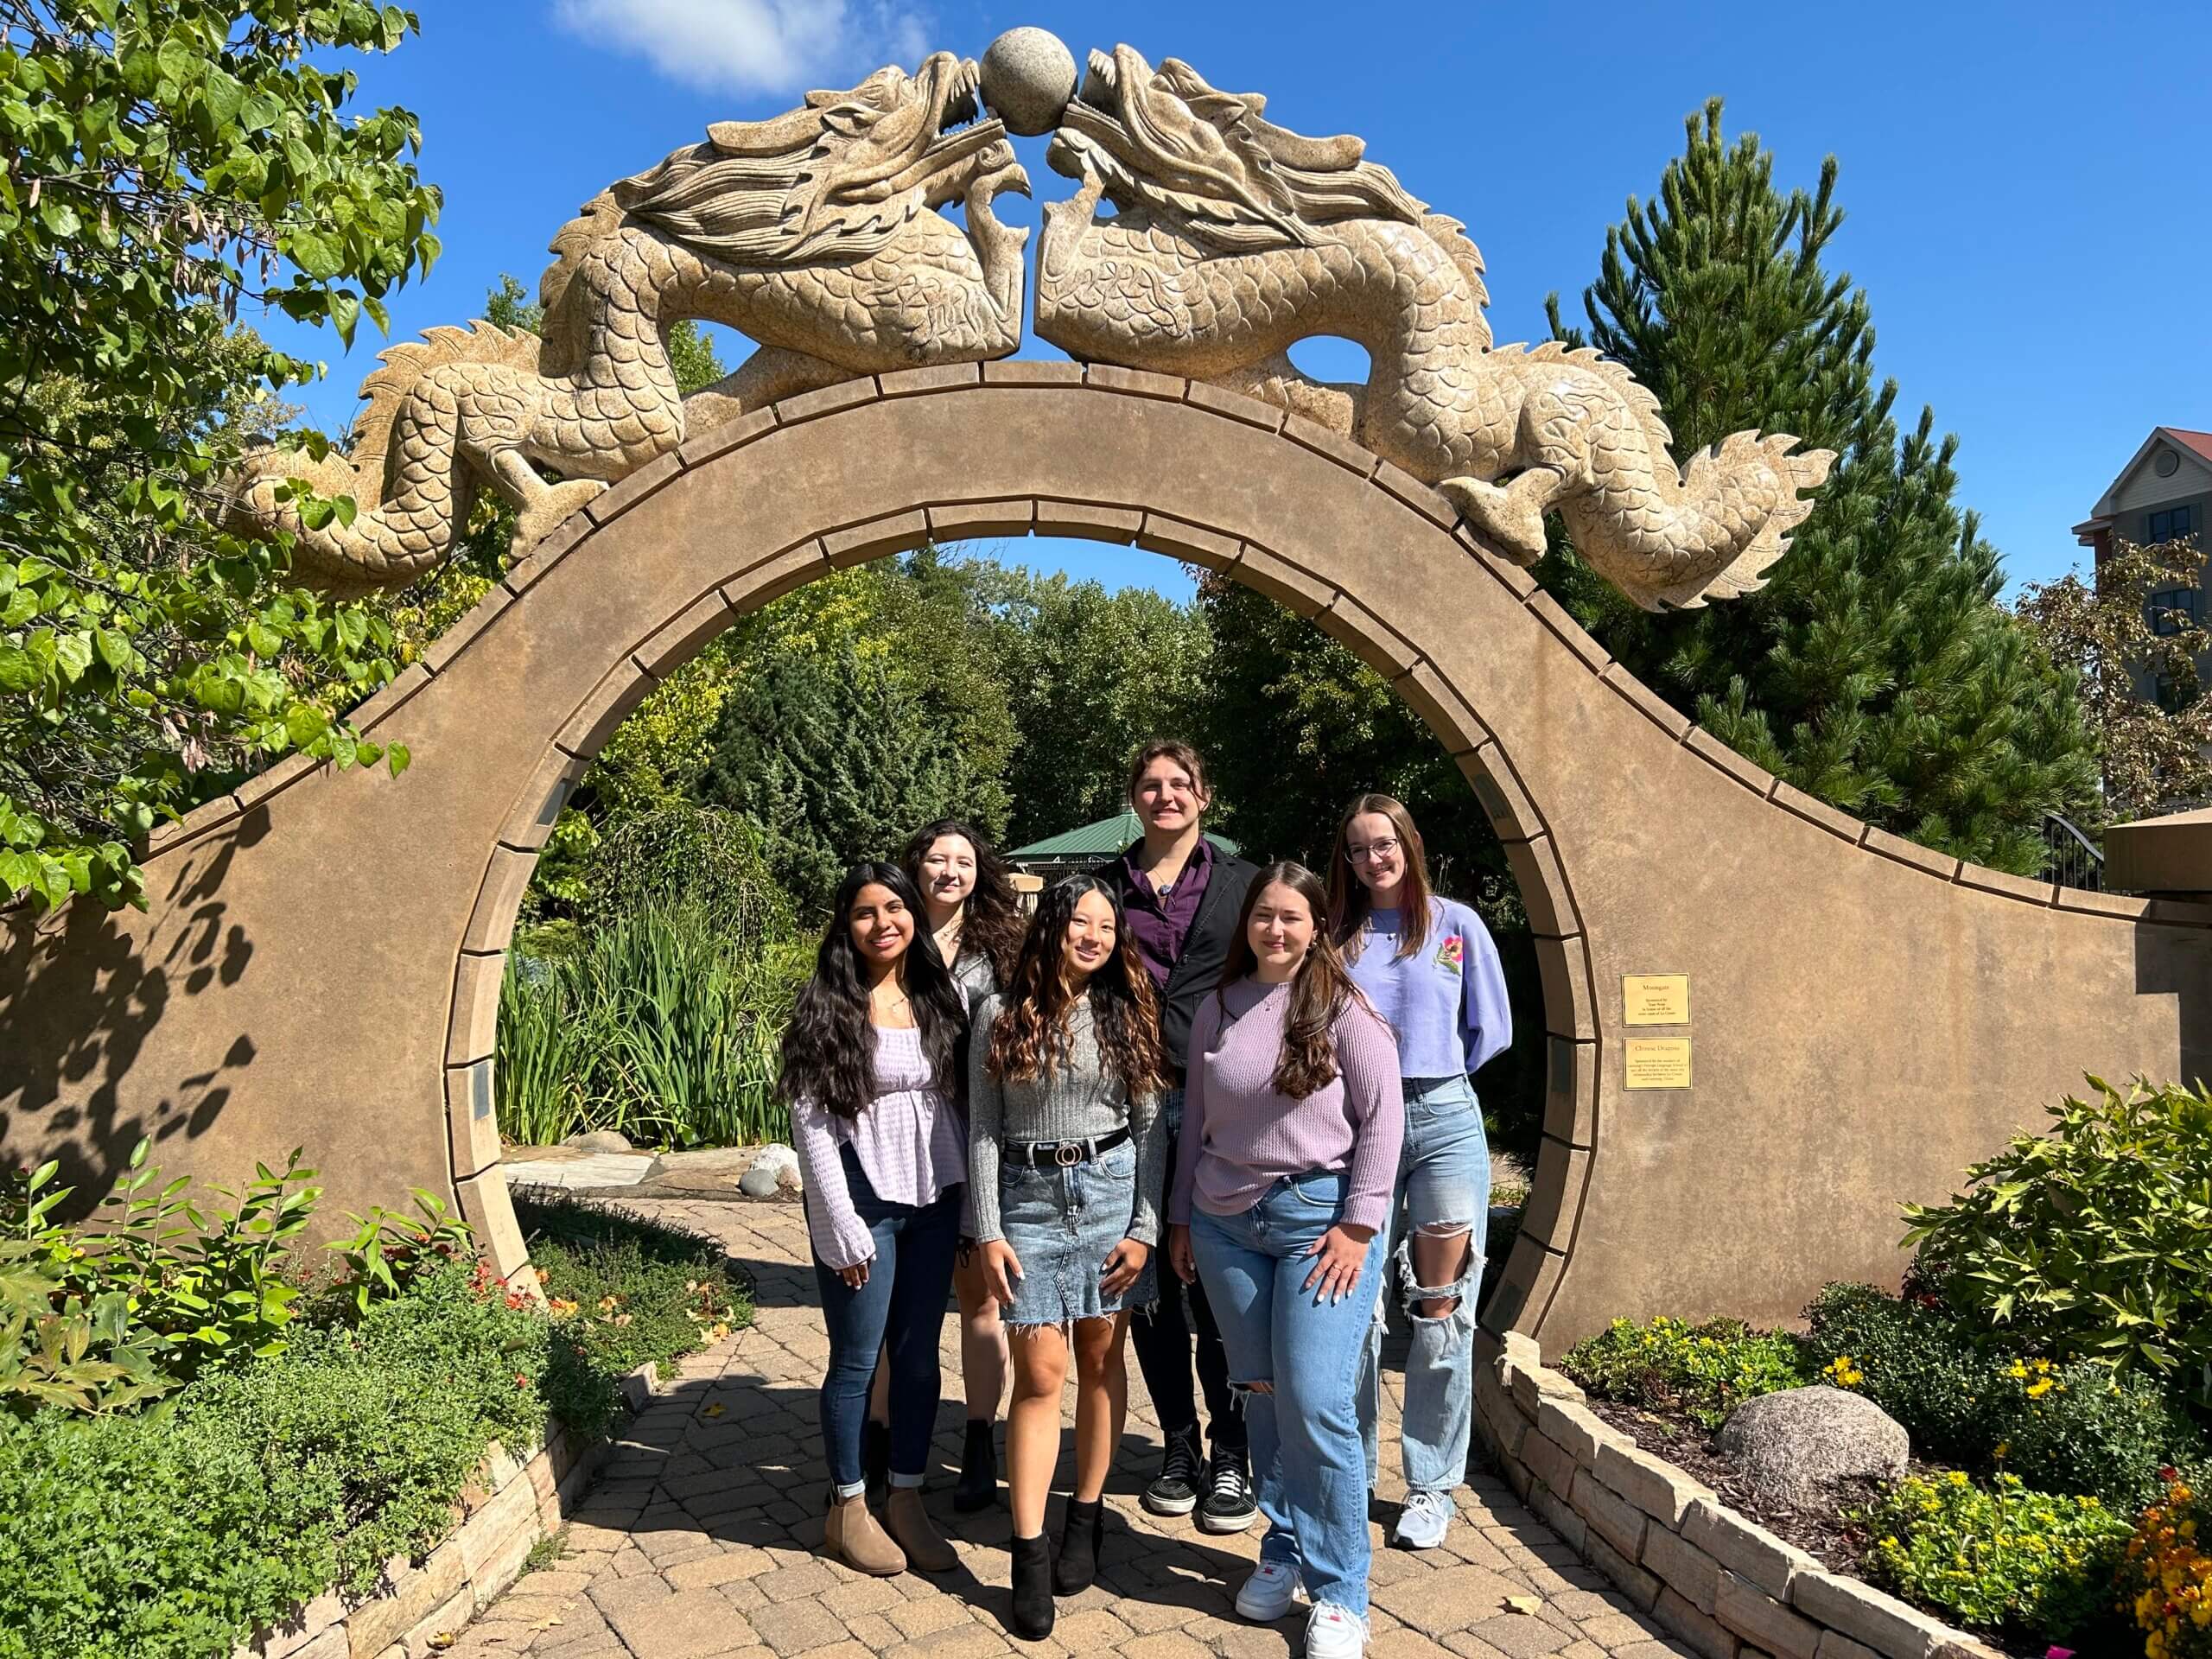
xmin=1852 ymin=1469 xmax=2128 ymax=1639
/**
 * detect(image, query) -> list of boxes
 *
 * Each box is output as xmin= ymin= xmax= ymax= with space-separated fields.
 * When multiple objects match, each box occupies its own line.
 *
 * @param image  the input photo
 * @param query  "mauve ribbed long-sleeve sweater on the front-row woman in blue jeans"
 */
xmin=1168 ymin=980 xmax=1405 ymax=1230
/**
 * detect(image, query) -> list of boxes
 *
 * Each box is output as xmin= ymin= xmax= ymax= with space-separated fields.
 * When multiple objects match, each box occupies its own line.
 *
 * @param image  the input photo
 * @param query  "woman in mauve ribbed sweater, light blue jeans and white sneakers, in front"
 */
xmin=1168 ymin=862 xmax=1402 ymax=1659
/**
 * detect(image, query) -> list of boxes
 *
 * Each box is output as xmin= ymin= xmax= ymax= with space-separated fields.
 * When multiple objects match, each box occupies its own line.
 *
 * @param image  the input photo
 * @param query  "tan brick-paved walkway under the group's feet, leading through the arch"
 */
xmin=447 ymin=1201 xmax=1688 ymax=1659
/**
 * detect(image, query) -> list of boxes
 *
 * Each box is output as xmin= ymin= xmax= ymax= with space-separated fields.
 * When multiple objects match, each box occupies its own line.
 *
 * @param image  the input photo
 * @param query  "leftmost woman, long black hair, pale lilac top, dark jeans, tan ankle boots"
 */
xmin=779 ymin=862 xmax=967 ymax=1575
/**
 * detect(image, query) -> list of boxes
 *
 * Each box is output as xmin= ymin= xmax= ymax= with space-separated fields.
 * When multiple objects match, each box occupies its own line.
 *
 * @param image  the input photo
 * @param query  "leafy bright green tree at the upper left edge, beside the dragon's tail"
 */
xmin=0 ymin=0 xmax=438 ymax=905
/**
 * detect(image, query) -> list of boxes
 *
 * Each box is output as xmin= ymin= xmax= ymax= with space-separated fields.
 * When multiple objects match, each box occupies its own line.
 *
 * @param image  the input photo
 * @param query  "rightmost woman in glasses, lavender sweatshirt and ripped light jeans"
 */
xmin=1330 ymin=794 xmax=1513 ymax=1548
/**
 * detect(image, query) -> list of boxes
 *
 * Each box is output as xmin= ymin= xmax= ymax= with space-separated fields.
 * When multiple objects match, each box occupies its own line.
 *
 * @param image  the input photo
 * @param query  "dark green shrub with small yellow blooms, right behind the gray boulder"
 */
xmin=1805 ymin=1285 xmax=2203 ymax=1506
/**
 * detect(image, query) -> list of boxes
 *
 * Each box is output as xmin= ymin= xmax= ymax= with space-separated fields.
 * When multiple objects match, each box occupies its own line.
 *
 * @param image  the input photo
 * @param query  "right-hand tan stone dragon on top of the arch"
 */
xmin=1035 ymin=47 xmax=1834 ymax=611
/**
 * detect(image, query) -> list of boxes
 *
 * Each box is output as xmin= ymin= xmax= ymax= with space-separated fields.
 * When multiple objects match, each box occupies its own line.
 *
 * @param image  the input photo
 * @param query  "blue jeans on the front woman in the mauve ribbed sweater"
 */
xmin=1190 ymin=1170 xmax=1382 ymax=1617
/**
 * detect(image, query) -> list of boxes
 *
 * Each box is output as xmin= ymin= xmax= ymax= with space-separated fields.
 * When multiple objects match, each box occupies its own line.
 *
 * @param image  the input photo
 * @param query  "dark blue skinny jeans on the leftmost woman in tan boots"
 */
xmin=814 ymin=1146 xmax=963 ymax=1486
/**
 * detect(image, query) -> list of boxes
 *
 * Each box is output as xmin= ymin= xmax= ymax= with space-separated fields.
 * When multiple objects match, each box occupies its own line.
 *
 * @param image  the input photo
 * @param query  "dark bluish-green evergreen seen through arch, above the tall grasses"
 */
xmin=699 ymin=639 xmax=976 ymax=913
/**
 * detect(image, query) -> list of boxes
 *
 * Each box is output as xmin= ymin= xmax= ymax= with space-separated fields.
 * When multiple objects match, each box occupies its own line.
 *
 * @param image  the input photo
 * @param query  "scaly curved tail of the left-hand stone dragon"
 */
xmin=228 ymin=323 xmax=537 ymax=595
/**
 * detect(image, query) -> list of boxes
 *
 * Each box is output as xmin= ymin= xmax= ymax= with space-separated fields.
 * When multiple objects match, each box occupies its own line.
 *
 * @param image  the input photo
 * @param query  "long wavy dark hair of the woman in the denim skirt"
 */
xmin=988 ymin=876 xmax=1168 ymax=1099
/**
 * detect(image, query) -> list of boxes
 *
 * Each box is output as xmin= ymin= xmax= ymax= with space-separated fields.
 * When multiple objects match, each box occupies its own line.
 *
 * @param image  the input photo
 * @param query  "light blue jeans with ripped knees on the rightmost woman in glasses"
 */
xmin=1360 ymin=1077 xmax=1491 ymax=1491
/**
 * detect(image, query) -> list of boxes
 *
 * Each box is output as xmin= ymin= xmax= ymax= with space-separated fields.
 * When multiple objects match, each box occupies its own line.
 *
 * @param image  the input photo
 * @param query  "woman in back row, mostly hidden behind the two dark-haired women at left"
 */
xmin=862 ymin=818 xmax=1022 ymax=1513
